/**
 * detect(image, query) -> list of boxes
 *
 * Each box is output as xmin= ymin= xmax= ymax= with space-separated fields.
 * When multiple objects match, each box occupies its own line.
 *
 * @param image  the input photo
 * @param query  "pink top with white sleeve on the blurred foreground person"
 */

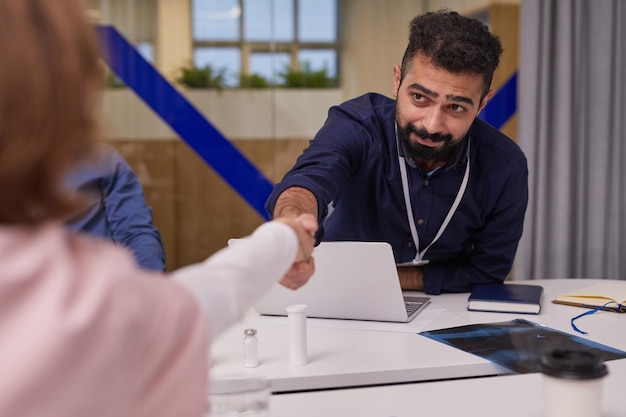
xmin=0 ymin=219 xmax=298 ymax=417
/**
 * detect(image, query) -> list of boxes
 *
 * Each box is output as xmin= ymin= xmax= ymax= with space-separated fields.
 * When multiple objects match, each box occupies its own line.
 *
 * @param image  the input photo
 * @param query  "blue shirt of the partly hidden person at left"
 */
xmin=65 ymin=144 xmax=165 ymax=271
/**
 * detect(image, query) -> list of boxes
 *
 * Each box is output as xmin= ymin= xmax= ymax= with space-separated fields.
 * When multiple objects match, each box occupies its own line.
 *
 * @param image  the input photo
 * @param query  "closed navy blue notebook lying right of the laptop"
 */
xmin=467 ymin=284 xmax=543 ymax=314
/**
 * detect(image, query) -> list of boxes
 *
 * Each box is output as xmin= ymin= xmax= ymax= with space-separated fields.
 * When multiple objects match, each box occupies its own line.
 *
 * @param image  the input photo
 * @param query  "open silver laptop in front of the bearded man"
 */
xmin=228 ymin=239 xmax=430 ymax=322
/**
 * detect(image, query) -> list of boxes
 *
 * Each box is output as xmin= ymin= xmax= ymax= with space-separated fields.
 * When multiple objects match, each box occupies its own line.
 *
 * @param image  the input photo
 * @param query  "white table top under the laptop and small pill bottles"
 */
xmin=210 ymin=279 xmax=626 ymax=397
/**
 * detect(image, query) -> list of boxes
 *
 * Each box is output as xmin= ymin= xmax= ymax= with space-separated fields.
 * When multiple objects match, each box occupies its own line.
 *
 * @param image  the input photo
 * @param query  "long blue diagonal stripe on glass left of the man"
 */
xmin=96 ymin=25 xmax=272 ymax=220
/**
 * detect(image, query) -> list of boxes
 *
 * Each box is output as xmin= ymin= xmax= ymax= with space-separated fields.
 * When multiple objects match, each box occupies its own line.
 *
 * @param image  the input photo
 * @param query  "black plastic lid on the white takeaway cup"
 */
xmin=541 ymin=349 xmax=609 ymax=379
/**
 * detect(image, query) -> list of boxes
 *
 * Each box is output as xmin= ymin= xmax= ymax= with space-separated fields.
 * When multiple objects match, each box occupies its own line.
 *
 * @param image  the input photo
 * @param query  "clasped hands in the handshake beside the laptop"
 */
xmin=275 ymin=214 xmax=318 ymax=290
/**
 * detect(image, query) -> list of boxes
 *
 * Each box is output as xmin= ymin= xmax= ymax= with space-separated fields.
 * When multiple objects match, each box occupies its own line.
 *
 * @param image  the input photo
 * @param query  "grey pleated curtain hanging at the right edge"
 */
xmin=514 ymin=0 xmax=626 ymax=279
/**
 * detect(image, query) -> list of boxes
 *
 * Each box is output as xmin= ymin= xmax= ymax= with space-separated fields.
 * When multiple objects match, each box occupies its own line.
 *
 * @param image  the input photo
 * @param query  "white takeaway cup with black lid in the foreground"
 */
xmin=541 ymin=349 xmax=608 ymax=417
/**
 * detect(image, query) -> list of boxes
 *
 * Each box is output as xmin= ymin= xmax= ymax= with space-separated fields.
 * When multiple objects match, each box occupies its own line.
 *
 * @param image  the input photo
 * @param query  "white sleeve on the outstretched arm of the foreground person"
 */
xmin=171 ymin=222 xmax=299 ymax=339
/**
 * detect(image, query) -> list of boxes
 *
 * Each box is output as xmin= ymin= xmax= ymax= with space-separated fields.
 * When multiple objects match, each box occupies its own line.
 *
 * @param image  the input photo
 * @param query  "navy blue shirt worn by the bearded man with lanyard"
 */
xmin=266 ymin=93 xmax=528 ymax=294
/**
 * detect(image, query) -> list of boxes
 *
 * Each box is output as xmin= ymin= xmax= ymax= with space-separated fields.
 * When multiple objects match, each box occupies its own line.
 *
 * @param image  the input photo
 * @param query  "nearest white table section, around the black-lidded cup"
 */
xmin=269 ymin=359 xmax=626 ymax=417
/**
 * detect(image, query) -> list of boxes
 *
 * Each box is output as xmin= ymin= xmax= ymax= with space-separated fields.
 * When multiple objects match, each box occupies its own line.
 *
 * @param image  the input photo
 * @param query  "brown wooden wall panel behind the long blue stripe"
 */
xmin=108 ymin=139 xmax=308 ymax=270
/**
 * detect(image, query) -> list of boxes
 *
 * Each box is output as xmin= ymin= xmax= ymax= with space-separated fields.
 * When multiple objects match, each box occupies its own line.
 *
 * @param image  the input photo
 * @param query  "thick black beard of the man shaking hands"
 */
xmin=396 ymin=122 xmax=462 ymax=161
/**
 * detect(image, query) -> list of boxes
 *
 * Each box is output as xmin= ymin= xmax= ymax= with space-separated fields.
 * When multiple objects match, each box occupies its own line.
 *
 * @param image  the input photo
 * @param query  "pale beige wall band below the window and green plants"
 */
xmin=102 ymin=89 xmax=342 ymax=140
